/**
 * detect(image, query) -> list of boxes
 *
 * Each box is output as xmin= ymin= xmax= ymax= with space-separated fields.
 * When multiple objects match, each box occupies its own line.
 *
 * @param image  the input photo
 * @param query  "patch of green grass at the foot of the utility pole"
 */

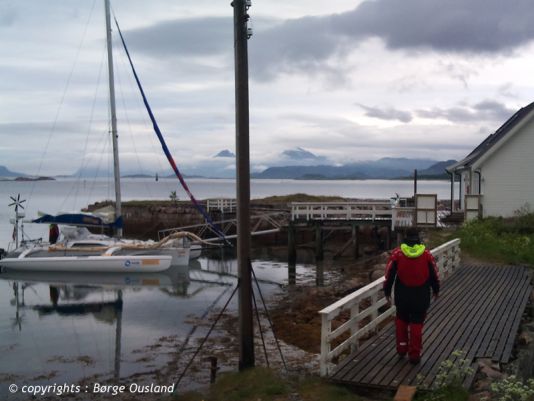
xmin=174 ymin=367 xmax=363 ymax=401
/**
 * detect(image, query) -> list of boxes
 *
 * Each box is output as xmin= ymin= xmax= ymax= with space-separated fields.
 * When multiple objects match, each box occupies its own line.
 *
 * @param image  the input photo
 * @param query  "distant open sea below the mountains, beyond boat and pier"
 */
xmin=0 ymin=179 xmax=450 ymax=248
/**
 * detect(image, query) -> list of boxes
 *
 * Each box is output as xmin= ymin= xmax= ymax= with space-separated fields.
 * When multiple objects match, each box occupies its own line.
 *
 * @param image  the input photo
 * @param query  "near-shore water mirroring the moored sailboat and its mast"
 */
xmin=0 ymin=252 xmax=302 ymax=400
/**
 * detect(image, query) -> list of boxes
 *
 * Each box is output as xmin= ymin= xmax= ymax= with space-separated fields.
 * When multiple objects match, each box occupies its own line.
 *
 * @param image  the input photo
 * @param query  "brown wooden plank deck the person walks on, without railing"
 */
xmin=330 ymin=266 xmax=531 ymax=389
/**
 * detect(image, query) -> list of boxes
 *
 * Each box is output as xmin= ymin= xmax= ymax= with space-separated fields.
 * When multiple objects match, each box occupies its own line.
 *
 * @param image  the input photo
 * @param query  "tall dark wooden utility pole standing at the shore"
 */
xmin=232 ymin=0 xmax=254 ymax=370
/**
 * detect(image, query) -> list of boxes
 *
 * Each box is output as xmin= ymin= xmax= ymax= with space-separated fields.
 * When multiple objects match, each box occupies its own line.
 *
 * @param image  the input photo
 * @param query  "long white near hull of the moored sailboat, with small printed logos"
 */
xmin=0 ymin=255 xmax=172 ymax=273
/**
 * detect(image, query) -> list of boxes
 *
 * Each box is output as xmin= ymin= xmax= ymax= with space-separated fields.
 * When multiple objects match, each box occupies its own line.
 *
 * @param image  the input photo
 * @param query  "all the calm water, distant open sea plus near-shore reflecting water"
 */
xmin=0 ymin=179 xmax=449 ymax=400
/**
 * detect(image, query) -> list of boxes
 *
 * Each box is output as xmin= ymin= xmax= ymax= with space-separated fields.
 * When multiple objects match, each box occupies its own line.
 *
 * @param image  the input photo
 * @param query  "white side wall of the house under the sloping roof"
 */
xmin=480 ymin=120 xmax=534 ymax=217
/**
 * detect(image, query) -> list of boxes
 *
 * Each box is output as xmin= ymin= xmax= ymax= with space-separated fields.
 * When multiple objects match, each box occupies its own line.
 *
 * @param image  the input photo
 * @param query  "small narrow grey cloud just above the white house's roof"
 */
xmin=417 ymin=100 xmax=516 ymax=123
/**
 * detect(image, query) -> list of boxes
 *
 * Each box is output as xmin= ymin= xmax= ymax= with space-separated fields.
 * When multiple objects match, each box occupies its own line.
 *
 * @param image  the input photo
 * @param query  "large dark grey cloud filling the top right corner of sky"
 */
xmin=336 ymin=0 xmax=534 ymax=53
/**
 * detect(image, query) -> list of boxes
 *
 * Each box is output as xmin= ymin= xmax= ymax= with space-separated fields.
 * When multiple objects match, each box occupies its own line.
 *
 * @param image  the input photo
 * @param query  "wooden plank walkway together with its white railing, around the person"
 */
xmin=320 ymin=239 xmax=532 ymax=389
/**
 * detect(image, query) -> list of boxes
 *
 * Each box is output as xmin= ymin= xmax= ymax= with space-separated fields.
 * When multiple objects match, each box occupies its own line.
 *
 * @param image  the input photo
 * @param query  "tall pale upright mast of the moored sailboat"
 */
xmin=104 ymin=0 xmax=122 ymax=237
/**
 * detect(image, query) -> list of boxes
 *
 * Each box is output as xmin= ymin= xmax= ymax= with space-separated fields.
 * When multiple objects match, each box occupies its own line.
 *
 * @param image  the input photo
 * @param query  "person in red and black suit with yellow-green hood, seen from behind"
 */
xmin=384 ymin=228 xmax=440 ymax=364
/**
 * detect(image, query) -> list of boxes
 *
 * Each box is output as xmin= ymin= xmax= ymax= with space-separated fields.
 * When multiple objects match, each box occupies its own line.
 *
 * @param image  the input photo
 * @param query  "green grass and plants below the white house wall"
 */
xmin=458 ymin=213 xmax=534 ymax=265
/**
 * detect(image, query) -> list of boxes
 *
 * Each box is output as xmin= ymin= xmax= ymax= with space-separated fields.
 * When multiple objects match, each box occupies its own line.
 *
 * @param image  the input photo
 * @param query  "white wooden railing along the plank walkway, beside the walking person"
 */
xmin=319 ymin=239 xmax=460 ymax=376
